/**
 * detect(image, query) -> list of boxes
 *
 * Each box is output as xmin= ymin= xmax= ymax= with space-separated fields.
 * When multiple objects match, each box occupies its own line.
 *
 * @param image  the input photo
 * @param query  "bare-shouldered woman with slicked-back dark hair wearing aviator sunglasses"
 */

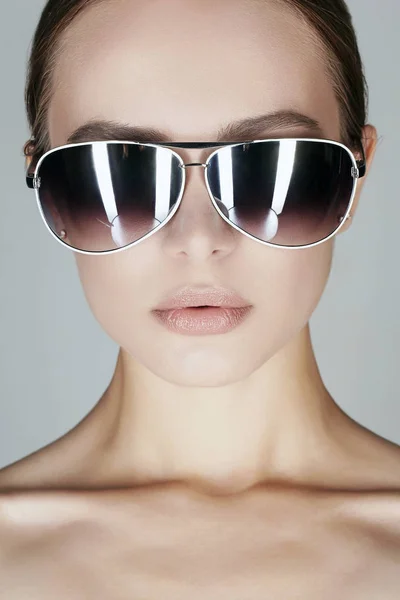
xmin=0 ymin=0 xmax=400 ymax=600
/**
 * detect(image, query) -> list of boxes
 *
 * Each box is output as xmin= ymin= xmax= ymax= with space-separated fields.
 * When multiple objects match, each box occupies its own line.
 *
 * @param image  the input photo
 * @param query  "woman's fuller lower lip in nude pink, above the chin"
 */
xmin=153 ymin=306 xmax=253 ymax=335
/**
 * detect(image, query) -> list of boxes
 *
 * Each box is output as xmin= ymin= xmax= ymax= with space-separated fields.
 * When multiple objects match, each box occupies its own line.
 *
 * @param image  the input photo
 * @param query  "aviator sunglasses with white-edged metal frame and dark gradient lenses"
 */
xmin=26 ymin=138 xmax=366 ymax=254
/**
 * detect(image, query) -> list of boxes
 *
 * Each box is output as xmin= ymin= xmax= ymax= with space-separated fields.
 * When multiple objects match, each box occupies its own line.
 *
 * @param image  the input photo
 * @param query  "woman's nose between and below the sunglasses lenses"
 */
xmin=163 ymin=162 xmax=240 ymax=262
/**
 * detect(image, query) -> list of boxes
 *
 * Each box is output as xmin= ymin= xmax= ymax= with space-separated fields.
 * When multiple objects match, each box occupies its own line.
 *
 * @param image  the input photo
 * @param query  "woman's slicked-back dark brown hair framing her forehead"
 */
xmin=25 ymin=0 xmax=368 ymax=157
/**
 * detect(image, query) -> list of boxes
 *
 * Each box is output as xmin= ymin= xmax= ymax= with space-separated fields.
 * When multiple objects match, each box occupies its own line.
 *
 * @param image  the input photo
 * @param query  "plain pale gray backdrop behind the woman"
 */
xmin=0 ymin=0 xmax=400 ymax=467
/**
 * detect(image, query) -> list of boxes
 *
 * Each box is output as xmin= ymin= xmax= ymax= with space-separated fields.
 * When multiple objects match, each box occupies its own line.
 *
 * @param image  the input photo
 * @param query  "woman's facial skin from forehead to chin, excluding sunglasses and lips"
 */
xmin=49 ymin=0 xmax=356 ymax=386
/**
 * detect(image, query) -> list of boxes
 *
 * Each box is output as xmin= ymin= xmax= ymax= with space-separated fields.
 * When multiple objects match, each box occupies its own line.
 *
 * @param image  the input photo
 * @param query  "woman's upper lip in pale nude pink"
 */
xmin=154 ymin=286 xmax=251 ymax=310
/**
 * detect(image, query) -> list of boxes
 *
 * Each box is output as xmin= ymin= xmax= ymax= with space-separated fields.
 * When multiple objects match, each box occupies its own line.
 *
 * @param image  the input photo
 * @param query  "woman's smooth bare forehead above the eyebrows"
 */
xmin=49 ymin=0 xmax=339 ymax=146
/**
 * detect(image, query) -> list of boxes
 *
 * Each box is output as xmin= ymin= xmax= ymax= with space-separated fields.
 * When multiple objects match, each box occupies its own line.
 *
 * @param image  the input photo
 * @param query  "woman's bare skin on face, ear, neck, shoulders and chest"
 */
xmin=0 ymin=0 xmax=400 ymax=600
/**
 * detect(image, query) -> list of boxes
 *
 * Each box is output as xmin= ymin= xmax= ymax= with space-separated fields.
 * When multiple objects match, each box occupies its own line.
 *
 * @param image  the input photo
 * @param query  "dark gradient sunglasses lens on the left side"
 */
xmin=37 ymin=142 xmax=184 ymax=252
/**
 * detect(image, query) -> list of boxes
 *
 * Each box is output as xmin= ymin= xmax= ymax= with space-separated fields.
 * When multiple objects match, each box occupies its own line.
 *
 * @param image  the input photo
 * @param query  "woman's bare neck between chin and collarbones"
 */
xmin=82 ymin=326 xmax=351 ymax=492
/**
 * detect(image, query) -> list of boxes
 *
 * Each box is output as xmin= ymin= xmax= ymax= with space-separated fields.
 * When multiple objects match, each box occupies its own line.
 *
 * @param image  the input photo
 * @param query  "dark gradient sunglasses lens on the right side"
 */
xmin=206 ymin=139 xmax=355 ymax=246
